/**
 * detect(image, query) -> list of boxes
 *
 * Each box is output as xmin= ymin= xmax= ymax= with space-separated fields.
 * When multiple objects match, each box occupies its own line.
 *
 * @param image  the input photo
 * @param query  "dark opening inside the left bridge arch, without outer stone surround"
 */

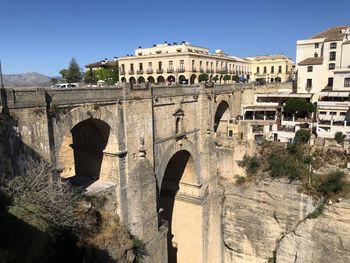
xmin=59 ymin=118 xmax=110 ymax=187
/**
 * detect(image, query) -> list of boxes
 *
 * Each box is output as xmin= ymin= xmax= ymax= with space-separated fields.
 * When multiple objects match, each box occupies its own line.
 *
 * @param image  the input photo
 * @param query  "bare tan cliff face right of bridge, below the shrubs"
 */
xmin=223 ymin=179 xmax=350 ymax=263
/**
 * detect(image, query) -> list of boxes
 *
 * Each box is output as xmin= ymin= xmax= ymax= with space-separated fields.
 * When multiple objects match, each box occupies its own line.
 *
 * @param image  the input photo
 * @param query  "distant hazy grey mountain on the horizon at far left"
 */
xmin=3 ymin=72 xmax=50 ymax=87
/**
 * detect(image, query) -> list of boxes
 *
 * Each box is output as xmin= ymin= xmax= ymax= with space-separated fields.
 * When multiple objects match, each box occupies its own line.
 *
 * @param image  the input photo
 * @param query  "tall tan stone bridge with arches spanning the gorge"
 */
xmin=0 ymin=84 xmax=290 ymax=263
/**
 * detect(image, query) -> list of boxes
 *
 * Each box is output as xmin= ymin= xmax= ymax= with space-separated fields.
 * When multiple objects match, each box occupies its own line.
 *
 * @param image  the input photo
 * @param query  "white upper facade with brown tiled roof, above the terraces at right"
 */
xmin=296 ymin=26 xmax=350 ymax=96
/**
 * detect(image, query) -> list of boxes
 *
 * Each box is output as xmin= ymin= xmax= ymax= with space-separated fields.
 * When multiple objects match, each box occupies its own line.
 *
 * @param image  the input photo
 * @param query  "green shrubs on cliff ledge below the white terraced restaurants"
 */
xmin=236 ymin=142 xmax=350 ymax=200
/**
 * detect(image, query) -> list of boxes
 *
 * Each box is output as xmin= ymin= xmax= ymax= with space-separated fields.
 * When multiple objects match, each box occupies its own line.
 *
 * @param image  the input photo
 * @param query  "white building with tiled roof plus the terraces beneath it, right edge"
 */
xmin=296 ymin=26 xmax=350 ymax=138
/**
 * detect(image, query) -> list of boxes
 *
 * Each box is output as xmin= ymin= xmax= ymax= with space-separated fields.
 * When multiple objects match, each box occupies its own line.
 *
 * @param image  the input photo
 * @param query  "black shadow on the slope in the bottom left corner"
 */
xmin=0 ymin=193 xmax=116 ymax=263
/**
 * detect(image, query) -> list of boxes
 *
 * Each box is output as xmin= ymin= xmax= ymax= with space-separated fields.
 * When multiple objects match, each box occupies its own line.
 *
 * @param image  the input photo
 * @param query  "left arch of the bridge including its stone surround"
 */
xmin=55 ymin=107 xmax=118 ymax=187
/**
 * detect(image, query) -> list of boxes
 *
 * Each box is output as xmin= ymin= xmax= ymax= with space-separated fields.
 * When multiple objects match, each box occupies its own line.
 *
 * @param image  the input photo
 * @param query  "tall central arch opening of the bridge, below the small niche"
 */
xmin=159 ymin=150 xmax=203 ymax=263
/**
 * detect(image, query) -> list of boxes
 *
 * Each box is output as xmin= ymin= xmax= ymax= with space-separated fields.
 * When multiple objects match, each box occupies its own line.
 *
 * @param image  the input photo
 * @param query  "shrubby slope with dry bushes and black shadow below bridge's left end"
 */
xmin=0 ymin=161 xmax=147 ymax=262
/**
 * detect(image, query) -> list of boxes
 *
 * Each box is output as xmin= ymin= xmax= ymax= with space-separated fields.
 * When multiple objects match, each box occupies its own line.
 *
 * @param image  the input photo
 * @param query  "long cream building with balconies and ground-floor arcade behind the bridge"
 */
xmin=118 ymin=42 xmax=251 ymax=84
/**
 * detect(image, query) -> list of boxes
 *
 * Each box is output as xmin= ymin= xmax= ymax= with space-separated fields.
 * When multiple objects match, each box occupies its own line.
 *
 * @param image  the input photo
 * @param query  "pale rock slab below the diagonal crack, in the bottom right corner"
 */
xmin=276 ymin=199 xmax=350 ymax=263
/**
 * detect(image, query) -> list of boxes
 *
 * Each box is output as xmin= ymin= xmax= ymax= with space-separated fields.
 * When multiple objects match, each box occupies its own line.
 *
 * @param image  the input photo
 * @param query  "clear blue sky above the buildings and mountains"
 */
xmin=0 ymin=0 xmax=350 ymax=76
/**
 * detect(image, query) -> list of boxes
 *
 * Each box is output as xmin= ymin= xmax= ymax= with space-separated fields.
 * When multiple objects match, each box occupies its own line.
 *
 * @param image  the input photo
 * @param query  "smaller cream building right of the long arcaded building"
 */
xmin=247 ymin=55 xmax=294 ymax=83
